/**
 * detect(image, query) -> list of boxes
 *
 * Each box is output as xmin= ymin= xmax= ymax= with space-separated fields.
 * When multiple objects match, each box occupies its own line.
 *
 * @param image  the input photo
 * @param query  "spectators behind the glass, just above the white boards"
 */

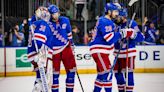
xmin=0 ymin=17 xmax=164 ymax=47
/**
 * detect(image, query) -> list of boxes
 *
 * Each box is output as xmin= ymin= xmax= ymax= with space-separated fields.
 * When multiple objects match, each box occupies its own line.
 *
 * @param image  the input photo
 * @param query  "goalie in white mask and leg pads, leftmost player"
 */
xmin=28 ymin=7 xmax=53 ymax=92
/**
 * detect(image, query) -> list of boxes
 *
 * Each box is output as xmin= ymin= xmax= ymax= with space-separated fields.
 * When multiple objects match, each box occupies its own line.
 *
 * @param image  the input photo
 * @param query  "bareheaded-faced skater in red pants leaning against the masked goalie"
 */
xmin=48 ymin=5 xmax=76 ymax=92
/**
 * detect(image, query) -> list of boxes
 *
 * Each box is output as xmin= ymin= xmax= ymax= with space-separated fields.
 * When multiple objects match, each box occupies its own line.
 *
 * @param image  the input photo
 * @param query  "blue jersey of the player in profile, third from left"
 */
xmin=89 ymin=17 xmax=121 ymax=54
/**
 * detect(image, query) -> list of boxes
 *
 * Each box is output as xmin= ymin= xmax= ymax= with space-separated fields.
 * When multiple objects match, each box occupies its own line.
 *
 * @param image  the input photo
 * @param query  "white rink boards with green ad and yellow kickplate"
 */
xmin=0 ymin=45 xmax=164 ymax=76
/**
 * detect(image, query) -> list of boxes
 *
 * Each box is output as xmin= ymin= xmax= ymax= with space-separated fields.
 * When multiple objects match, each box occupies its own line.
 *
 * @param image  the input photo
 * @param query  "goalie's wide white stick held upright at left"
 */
xmin=31 ymin=26 xmax=49 ymax=92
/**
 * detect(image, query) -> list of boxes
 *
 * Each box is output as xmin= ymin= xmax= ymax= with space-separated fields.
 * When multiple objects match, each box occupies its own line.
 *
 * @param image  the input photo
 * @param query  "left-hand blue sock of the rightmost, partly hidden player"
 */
xmin=115 ymin=72 xmax=125 ymax=92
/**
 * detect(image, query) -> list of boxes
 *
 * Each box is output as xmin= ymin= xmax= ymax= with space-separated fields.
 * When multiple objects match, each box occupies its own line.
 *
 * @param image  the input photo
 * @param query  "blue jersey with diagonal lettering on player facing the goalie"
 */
xmin=50 ymin=16 xmax=73 ymax=54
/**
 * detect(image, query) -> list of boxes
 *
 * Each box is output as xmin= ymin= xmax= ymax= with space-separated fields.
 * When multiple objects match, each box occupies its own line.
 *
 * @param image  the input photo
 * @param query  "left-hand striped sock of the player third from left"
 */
xmin=93 ymin=74 xmax=103 ymax=92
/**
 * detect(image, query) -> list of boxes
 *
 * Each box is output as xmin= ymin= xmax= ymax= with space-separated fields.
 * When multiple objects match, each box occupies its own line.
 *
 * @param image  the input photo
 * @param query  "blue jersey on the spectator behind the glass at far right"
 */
xmin=144 ymin=27 xmax=159 ymax=45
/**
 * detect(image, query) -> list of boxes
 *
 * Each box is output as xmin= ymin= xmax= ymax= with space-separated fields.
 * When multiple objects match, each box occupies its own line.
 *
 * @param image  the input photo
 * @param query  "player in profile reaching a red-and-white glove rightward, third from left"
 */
xmin=90 ymin=3 xmax=136 ymax=92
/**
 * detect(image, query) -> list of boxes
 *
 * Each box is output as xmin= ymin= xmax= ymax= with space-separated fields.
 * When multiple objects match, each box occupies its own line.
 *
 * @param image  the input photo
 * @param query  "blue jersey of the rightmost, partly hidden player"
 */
xmin=114 ymin=20 xmax=144 ymax=58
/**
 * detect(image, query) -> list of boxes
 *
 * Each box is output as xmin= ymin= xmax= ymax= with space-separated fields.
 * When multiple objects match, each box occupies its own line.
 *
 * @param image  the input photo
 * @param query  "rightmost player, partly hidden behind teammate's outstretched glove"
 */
xmin=114 ymin=8 xmax=144 ymax=92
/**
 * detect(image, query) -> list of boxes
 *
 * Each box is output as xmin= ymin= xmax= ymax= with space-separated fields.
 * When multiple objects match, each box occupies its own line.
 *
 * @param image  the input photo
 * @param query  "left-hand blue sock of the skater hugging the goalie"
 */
xmin=52 ymin=74 xmax=59 ymax=92
